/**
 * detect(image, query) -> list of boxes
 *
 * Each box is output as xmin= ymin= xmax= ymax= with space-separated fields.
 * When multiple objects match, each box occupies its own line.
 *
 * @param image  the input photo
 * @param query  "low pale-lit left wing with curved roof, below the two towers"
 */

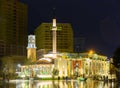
xmin=20 ymin=58 xmax=54 ymax=78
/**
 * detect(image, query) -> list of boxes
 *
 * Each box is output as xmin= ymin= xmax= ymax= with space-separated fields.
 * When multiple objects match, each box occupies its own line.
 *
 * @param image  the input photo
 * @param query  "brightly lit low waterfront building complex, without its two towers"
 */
xmin=19 ymin=53 xmax=110 ymax=79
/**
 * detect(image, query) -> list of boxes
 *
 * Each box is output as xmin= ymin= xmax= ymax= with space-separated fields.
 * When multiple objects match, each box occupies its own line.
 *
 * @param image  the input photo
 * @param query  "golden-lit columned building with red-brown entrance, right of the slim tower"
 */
xmin=66 ymin=53 xmax=110 ymax=77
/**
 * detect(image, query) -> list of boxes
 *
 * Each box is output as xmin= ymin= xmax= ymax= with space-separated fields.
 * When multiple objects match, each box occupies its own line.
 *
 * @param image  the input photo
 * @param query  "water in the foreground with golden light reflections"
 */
xmin=0 ymin=79 xmax=120 ymax=88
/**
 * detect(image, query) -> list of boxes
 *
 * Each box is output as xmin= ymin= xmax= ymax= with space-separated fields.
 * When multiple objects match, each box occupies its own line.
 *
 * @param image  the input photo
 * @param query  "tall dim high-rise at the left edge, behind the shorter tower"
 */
xmin=0 ymin=0 xmax=27 ymax=57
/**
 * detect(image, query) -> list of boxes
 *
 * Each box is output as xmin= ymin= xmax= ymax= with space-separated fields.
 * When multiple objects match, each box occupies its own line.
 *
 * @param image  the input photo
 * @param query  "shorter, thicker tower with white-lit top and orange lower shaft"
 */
xmin=27 ymin=35 xmax=36 ymax=62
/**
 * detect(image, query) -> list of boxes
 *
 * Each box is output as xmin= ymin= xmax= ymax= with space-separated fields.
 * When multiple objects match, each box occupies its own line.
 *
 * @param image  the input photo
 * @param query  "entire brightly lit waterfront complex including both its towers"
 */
xmin=19 ymin=19 xmax=110 ymax=78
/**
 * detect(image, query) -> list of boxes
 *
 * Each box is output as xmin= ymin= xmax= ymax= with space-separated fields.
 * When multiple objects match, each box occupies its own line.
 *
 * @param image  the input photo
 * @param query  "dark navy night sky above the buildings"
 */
xmin=21 ymin=0 xmax=120 ymax=57
